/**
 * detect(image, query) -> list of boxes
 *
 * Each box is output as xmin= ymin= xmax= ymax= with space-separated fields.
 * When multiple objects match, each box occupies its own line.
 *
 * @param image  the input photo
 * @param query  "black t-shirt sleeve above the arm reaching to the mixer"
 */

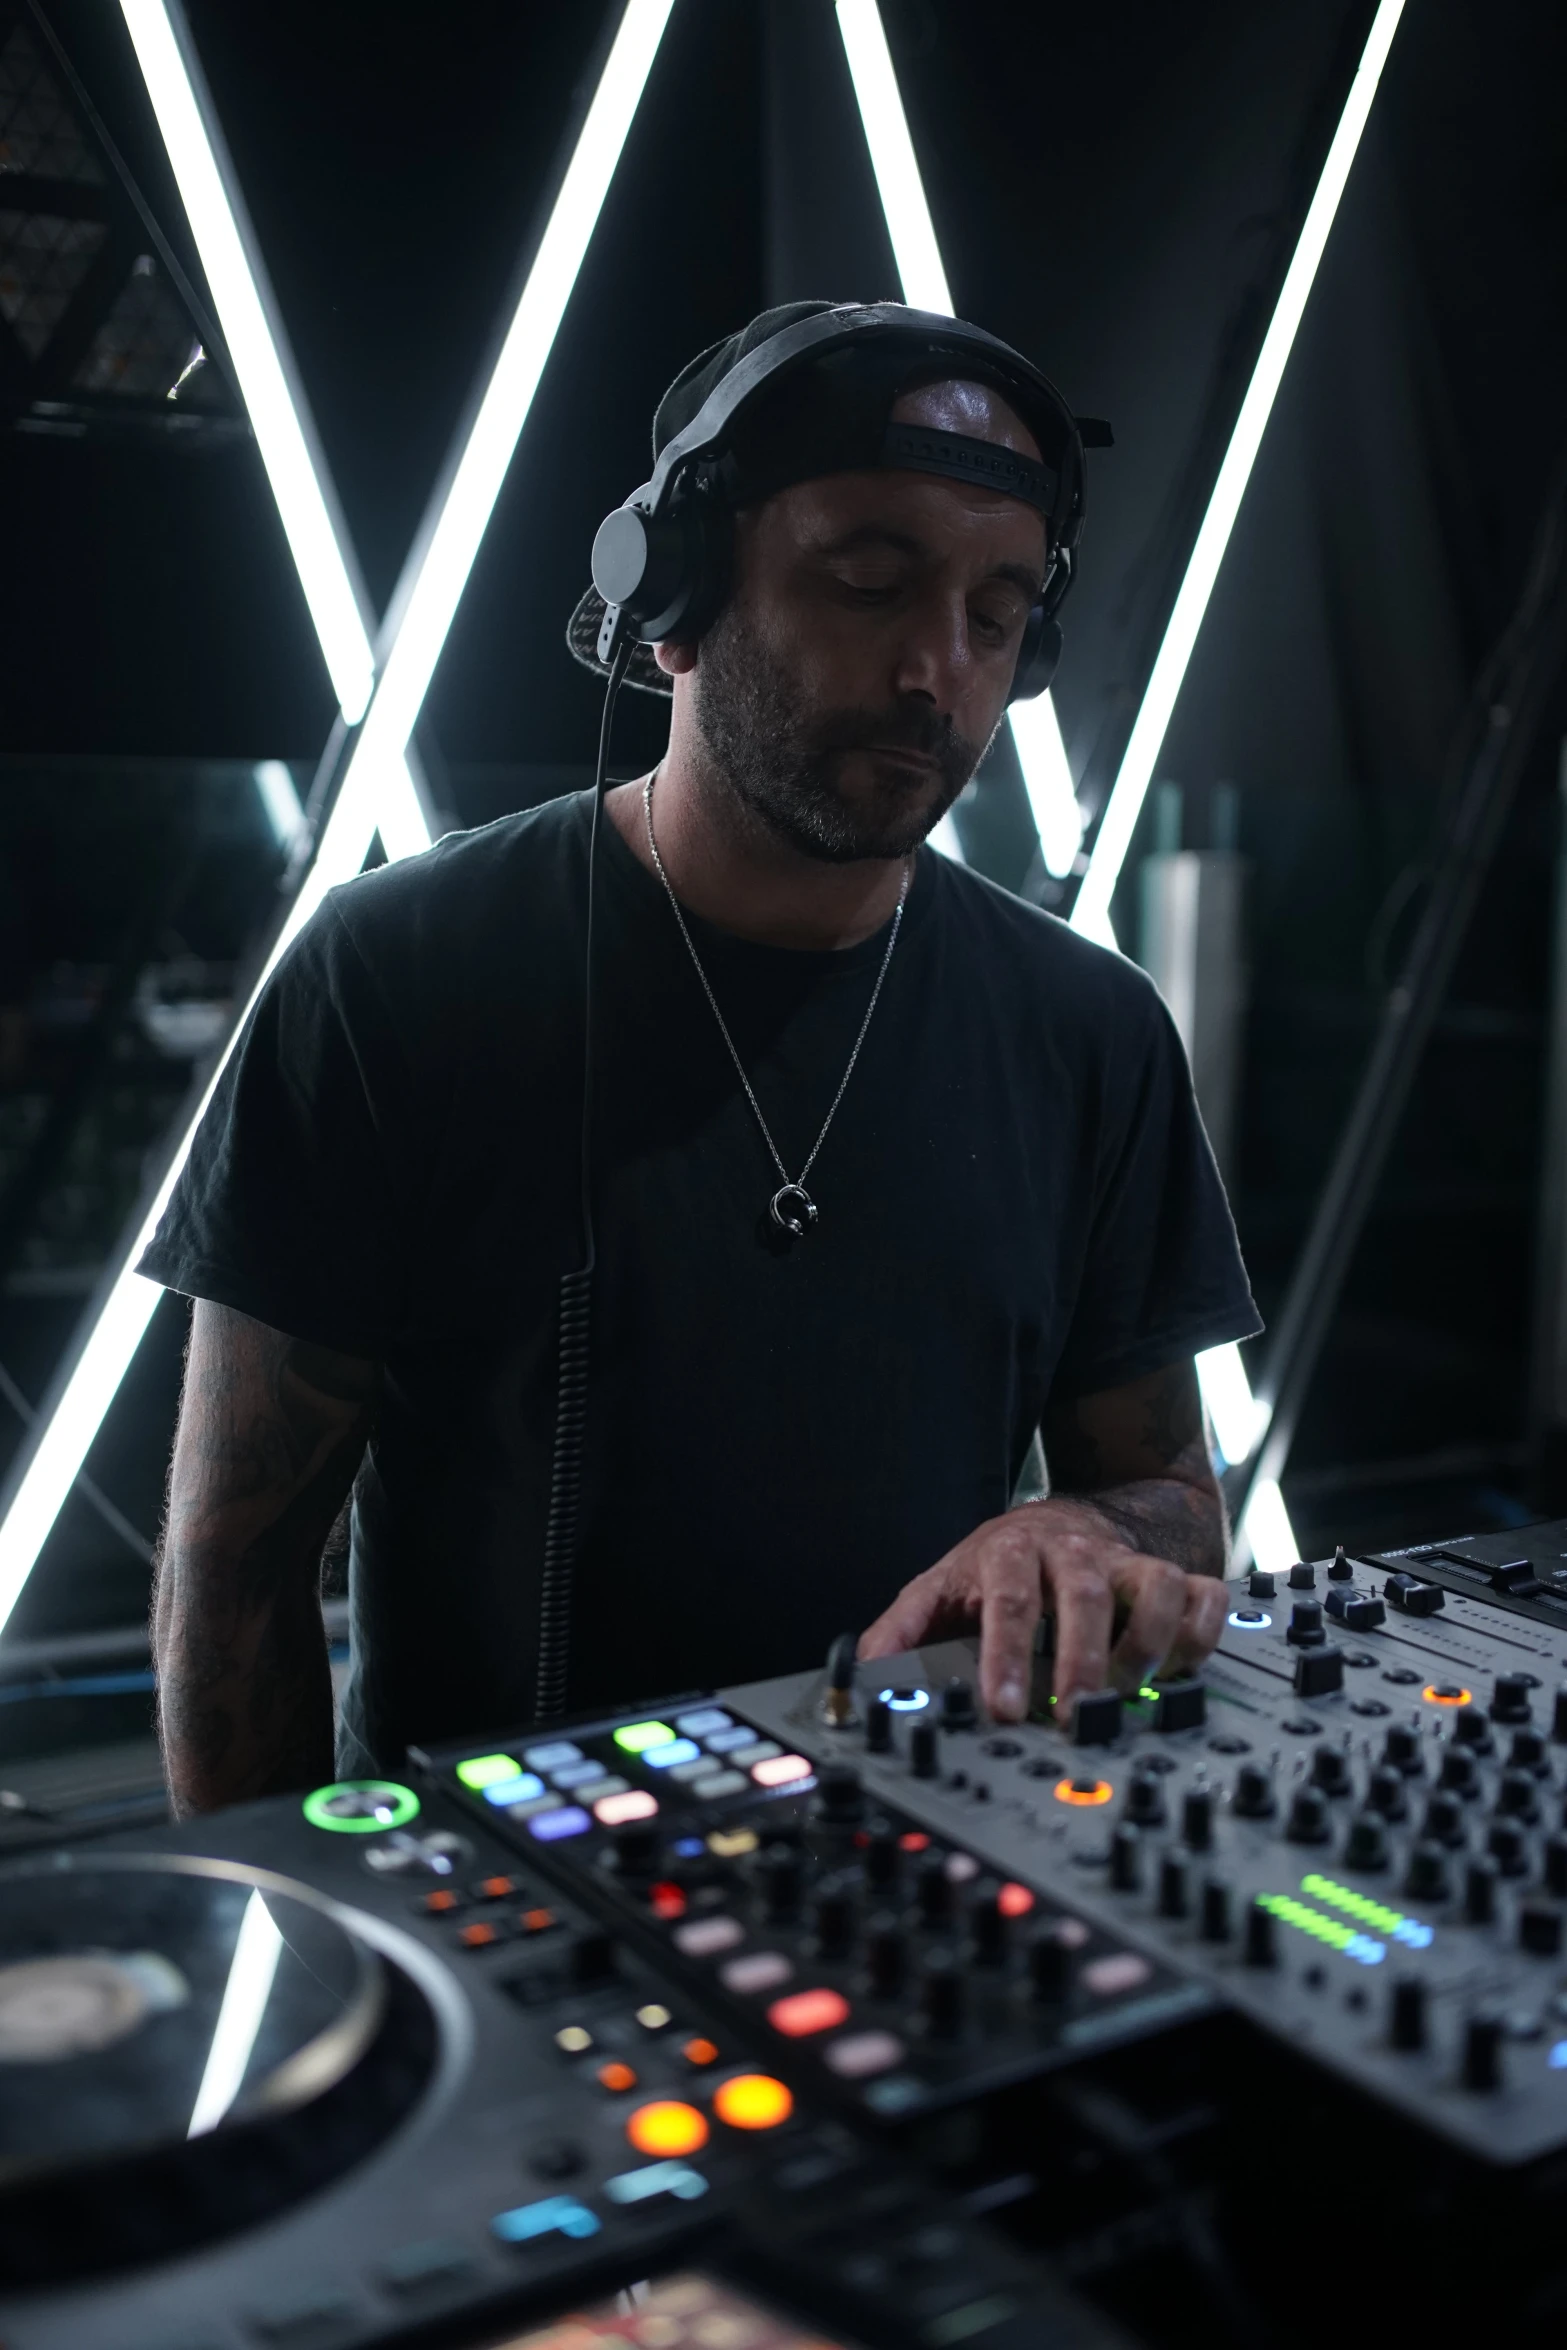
xmin=1050 ymin=975 xmax=1262 ymax=1398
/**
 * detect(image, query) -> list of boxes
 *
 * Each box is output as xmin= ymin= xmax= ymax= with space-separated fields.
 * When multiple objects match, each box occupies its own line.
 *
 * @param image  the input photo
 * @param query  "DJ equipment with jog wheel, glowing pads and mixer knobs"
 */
xmin=0 ymin=1523 xmax=1567 ymax=2350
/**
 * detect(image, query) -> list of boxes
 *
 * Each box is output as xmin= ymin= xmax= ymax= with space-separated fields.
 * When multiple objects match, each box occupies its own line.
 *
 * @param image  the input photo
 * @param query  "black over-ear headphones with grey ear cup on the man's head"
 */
xmin=592 ymin=303 xmax=1111 ymax=700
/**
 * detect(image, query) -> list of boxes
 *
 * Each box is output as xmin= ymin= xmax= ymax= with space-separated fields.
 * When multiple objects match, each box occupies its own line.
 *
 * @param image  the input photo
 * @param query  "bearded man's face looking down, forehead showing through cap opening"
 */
xmin=691 ymin=383 xmax=1045 ymax=862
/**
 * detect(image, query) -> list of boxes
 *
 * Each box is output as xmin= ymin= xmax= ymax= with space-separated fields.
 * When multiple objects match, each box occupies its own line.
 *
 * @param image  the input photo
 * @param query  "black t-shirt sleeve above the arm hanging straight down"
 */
xmin=136 ymin=898 xmax=409 ymax=1354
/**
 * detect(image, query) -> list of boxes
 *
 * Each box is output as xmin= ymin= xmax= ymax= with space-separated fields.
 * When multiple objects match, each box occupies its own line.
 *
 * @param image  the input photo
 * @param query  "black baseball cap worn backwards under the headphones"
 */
xmin=566 ymin=301 xmax=1111 ymax=696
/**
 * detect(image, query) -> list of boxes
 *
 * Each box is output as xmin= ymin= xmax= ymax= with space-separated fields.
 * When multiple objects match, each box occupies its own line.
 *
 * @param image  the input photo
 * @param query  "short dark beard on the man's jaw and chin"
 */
xmin=693 ymin=604 xmax=984 ymax=865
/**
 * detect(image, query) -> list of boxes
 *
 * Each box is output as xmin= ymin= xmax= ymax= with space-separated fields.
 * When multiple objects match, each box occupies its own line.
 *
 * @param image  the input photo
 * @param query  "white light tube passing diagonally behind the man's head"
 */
xmin=839 ymin=0 xmax=1083 ymax=881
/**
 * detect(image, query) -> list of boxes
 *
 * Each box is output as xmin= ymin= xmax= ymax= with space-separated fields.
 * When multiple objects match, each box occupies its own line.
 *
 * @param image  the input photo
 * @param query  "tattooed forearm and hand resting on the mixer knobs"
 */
xmin=860 ymin=1363 xmax=1229 ymax=1720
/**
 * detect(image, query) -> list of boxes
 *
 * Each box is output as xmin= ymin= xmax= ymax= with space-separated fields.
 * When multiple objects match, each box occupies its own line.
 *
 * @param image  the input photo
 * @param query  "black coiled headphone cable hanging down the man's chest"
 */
xmin=533 ymin=637 xmax=634 ymax=1723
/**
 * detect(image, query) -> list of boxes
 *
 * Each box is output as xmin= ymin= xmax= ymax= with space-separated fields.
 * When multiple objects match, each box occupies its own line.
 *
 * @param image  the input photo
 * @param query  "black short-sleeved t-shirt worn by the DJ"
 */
xmin=141 ymin=794 xmax=1259 ymax=1767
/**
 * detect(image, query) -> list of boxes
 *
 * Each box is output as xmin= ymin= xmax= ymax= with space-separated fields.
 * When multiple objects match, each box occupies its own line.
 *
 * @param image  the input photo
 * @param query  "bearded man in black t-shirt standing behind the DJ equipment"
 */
xmin=143 ymin=306 xmax=1257 ymax=1810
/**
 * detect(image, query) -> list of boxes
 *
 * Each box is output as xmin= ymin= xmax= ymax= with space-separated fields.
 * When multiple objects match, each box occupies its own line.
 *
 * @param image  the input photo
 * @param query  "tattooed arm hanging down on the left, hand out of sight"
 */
xmin=153 ymin=1302 xmax=381 ymax=1819
